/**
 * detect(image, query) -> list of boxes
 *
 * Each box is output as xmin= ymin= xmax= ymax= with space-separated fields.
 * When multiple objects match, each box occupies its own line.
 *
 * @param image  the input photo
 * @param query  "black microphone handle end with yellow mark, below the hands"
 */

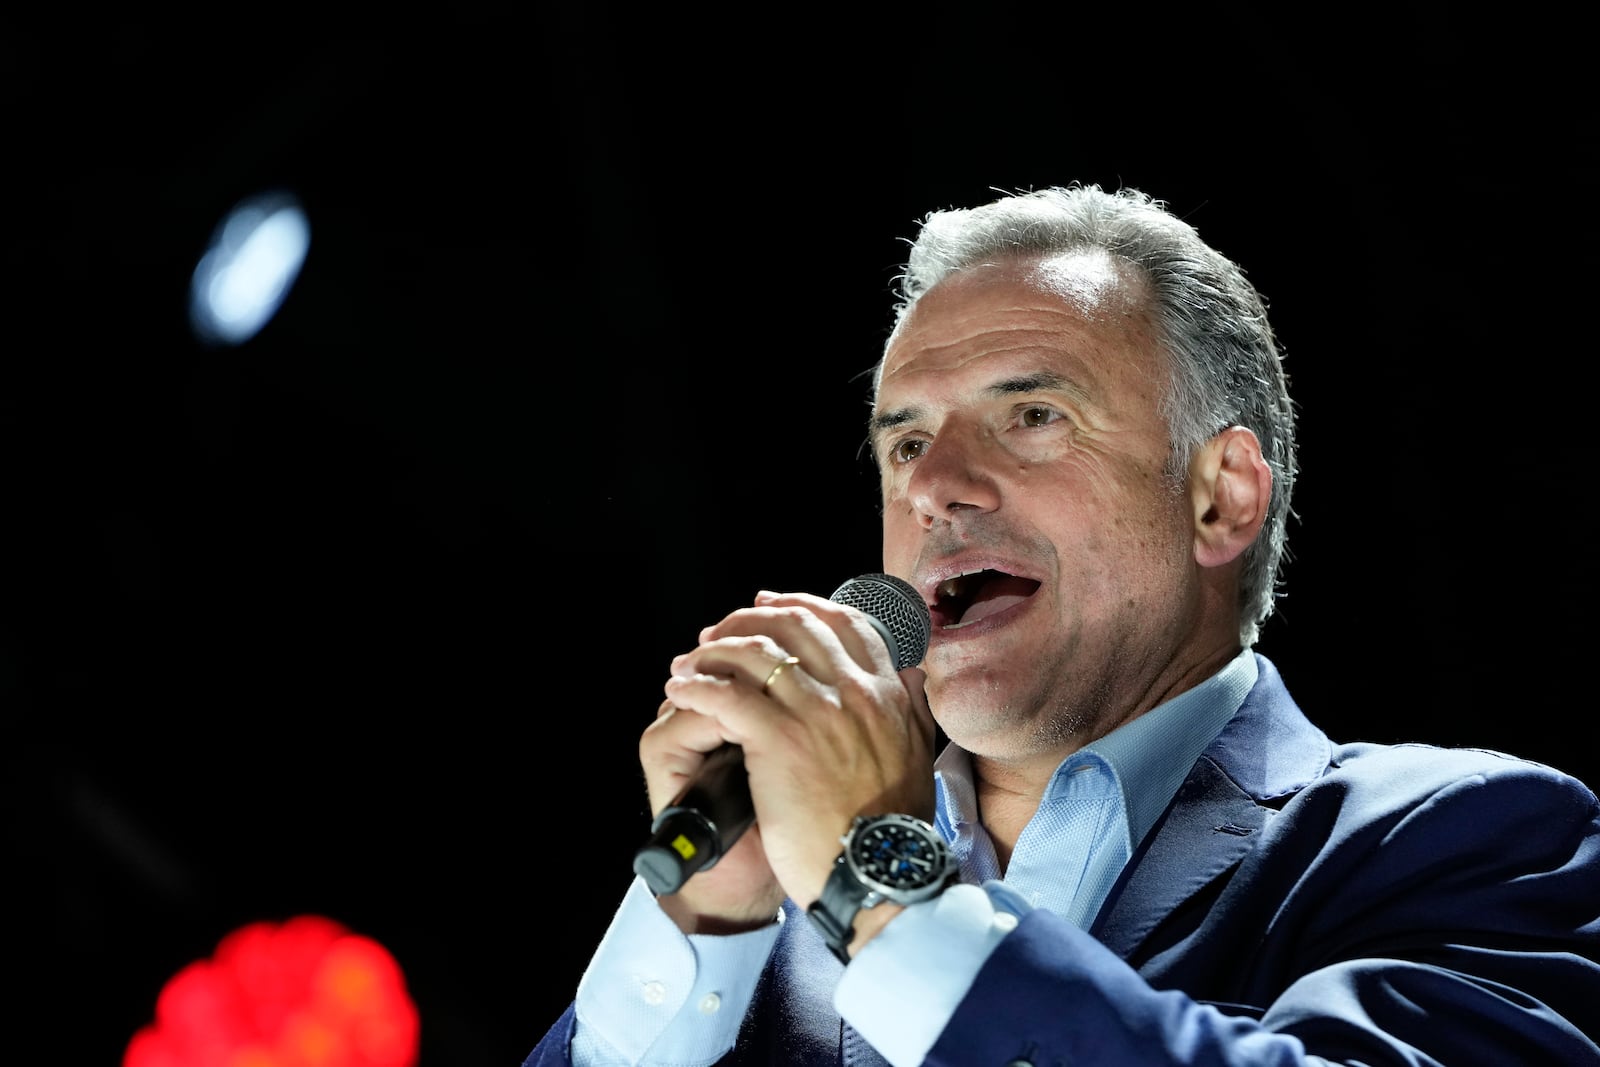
xmin=634 ymin=744 xmax=755 ymax=896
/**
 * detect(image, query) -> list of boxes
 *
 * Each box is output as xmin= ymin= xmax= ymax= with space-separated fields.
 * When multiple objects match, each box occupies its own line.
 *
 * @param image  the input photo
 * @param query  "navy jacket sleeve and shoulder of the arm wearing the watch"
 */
xmin=926 ymin=745 xmax=1600 ymax=1067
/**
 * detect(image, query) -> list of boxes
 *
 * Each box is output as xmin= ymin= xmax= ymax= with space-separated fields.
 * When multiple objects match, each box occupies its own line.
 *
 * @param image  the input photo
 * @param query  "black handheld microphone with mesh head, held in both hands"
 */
xmin=634 ymin=574 xmax=933 ymax=896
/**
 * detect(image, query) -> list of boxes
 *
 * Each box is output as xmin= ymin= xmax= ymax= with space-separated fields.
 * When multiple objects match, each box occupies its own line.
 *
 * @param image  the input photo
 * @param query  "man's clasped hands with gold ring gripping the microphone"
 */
xmin=640 ymin=592 xmax=934 ymax=933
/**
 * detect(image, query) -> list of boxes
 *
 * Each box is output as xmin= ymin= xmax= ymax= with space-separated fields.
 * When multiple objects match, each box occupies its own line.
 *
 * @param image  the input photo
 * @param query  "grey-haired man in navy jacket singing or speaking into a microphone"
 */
xmin=526 ymin=186 xmax=1600 ymax=1067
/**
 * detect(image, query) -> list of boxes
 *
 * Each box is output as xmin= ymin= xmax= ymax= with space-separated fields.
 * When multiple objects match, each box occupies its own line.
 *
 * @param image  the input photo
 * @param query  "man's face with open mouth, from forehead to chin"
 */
xmin=874 ymin=253 xmax=1200 ymax=758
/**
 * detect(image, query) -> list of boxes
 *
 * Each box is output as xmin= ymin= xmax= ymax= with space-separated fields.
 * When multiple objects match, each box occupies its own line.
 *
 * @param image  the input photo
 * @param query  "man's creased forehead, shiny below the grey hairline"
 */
xmin=878 ymin=250 xmax=1162 ymax=406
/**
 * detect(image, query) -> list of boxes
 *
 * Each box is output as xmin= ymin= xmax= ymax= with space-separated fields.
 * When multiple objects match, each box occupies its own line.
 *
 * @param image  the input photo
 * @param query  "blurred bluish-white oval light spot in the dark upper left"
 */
xmin=189 ymin=192 xmax=310 ymax=344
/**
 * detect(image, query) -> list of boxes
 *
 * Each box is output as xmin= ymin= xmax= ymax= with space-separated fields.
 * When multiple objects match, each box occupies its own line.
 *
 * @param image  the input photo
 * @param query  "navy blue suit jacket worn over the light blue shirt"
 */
xmin=526 ymin=656 xmax=1600 ymax=1067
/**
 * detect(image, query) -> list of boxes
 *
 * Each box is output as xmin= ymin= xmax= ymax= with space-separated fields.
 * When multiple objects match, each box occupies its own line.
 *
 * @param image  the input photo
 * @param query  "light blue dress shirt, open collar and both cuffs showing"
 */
xmin=573 ymin=648 xmax=1256 ymax=1067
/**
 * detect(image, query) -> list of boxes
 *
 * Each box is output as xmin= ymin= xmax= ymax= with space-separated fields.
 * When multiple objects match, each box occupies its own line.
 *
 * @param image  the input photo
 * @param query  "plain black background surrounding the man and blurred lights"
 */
xmin=0 ymin=3 xmax=1600 ymax=1067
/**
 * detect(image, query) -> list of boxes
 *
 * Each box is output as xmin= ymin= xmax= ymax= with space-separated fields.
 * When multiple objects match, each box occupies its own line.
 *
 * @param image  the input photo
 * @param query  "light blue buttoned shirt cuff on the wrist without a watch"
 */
xmin=573 ymin=878 xmax=782 ymax=1065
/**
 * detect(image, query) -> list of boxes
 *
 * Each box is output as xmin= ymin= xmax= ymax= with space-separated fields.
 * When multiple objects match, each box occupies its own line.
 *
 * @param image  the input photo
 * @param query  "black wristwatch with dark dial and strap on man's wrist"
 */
xmin=806 ymin=814 xmax=960 ymax=965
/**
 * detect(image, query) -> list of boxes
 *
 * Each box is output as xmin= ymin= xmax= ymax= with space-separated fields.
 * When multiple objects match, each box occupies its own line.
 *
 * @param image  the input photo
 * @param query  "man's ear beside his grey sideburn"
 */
xmin=1189 ymin=426 xmax=1272 ymax=566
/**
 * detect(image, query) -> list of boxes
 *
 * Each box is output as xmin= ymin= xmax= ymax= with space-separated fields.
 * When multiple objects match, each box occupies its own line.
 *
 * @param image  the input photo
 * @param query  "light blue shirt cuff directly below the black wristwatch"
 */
xmin=834 ymin=881 xmax=1029 ymax=1067
